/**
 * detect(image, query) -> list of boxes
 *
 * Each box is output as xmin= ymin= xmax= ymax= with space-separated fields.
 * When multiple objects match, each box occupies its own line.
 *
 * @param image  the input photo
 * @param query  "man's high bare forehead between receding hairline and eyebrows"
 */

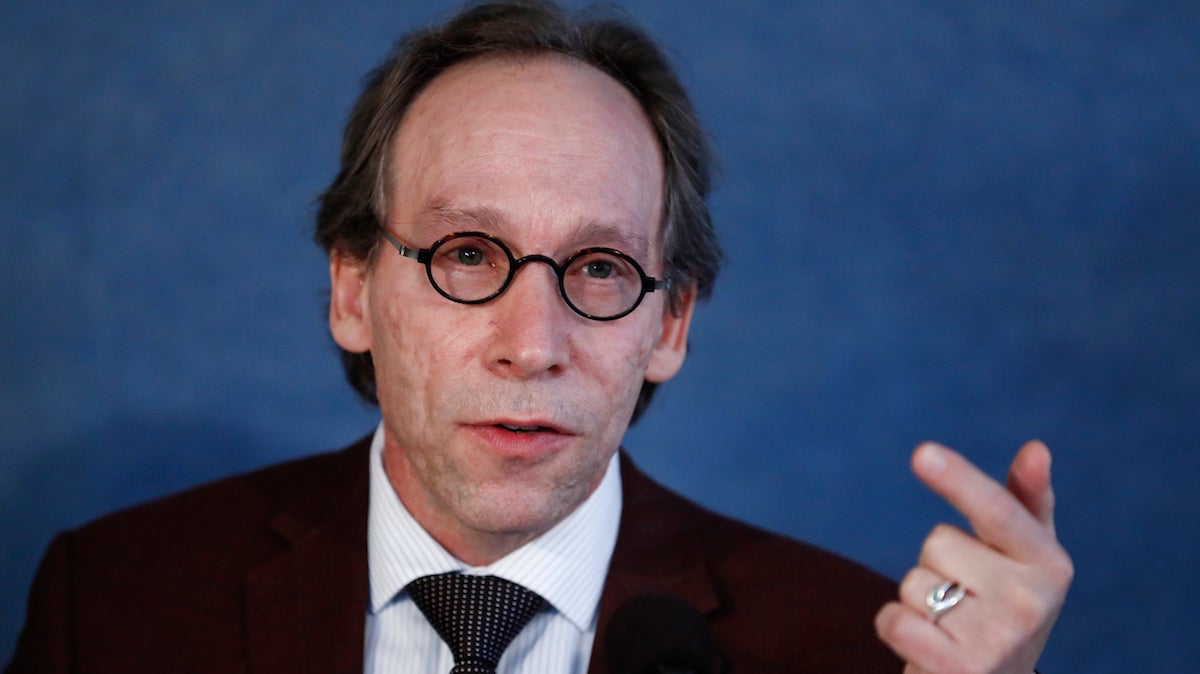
xmin=388 ymin=55 xmax=662 ymax=250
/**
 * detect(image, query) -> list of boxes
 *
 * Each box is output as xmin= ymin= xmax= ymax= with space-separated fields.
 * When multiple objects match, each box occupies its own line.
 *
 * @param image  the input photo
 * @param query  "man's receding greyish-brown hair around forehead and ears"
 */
xmin=316 ymin=0 xmax=721 ymax=420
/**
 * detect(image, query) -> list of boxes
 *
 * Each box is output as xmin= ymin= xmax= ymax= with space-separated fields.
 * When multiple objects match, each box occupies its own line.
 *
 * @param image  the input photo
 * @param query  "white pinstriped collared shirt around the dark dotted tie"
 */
xmin=364 ymin=423 xmax=622 ymax=674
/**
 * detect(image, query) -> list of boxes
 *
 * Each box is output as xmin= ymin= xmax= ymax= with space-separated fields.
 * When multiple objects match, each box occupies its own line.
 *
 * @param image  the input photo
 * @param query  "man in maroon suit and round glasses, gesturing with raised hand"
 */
xmin=10 ymin=1 xmax=1072 ymax=672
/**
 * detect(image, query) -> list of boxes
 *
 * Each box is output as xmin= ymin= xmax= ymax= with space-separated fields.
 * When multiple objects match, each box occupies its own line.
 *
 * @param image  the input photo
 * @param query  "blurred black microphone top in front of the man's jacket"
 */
xmin=605 ymin=595 xmax=716 ymax=674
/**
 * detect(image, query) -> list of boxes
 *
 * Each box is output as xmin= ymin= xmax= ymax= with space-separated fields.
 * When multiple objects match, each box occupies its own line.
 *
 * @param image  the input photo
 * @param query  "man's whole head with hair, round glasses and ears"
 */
xmin=318 ymin=4 xmax=718 ymax=564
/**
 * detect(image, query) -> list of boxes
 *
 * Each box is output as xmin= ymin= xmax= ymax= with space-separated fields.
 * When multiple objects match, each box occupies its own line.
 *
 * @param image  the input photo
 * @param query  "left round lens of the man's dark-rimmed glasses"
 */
xmin=430 ymin=234 xmax=512 ymax=302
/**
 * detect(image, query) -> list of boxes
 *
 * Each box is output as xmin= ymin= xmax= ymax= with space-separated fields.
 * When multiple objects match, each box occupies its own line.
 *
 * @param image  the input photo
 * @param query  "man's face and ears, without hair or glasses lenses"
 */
xmin=330 ymin=56 xmax=691 ymax=564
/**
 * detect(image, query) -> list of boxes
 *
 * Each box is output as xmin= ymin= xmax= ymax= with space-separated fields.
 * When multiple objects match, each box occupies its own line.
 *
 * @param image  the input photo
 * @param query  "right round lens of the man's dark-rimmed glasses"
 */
xmin=563 ymin=249 xmax=642 ymax=318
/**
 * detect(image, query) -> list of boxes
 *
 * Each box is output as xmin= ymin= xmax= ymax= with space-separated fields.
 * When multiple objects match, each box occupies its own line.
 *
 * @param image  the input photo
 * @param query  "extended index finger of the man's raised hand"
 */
xmin=912 ymin=443 xmax=1057 ymax=561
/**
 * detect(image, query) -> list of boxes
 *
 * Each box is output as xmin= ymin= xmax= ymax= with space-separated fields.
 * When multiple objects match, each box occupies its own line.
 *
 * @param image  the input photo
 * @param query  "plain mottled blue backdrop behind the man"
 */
xmin=0 ymin=0 xmax=1200 ymax=673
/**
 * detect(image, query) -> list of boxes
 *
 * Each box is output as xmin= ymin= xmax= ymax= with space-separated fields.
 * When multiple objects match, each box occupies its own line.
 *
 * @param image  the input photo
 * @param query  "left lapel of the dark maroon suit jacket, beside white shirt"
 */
xmin=246 ymin=440 xmax=370 ymax=674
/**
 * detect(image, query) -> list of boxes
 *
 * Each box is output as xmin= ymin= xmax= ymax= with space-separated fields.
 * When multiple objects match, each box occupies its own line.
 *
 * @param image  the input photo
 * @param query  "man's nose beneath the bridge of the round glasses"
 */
xmin=480 ymin=255 xmax=578 ymax=379
